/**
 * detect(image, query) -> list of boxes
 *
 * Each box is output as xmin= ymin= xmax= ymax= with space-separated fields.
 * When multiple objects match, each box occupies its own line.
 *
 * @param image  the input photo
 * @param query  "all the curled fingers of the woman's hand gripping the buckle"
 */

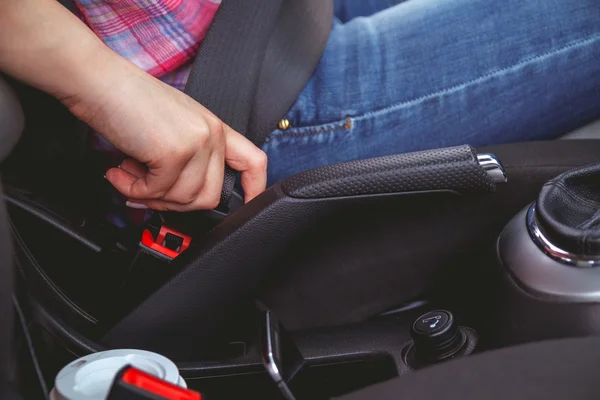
xmin=106 ymin=123 xmax=267 ymax=212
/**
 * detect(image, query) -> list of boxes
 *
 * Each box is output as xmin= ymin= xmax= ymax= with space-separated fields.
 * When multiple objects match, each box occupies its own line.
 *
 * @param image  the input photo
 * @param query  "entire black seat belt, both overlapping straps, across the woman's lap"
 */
xmin=185 ymin=0 xmax=333 ymax=206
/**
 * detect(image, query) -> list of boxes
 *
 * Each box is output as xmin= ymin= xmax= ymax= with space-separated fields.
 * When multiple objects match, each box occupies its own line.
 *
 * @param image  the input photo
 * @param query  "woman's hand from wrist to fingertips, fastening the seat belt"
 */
xmin=63 ymin=60 xmax=267 ymax=211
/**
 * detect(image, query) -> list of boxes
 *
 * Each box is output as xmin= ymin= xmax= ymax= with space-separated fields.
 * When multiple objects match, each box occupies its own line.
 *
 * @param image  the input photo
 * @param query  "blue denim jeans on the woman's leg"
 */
xmin=263 ymin=0 xmax=600 ymax=183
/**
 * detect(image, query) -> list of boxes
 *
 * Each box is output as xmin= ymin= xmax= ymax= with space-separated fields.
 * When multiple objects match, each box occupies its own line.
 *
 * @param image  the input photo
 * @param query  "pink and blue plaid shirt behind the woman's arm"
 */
xmin=76 ymin=0 xmax=221 ymax=227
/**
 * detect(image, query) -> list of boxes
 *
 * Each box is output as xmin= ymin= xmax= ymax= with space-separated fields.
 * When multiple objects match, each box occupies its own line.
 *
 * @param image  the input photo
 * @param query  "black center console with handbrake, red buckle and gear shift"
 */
xmin=7 ymin=143 xmax=600 ymax=399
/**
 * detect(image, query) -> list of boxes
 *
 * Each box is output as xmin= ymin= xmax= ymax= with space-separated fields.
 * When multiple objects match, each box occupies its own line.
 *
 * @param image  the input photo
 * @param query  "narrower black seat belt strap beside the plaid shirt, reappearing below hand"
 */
xmin=185 ymin=0 xmax=282 ymax=209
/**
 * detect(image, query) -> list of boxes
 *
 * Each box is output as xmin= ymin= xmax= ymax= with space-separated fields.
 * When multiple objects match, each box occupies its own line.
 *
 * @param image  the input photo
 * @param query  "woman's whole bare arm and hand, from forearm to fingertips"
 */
xmin=0 ymin=0 xmax=267 ymax=211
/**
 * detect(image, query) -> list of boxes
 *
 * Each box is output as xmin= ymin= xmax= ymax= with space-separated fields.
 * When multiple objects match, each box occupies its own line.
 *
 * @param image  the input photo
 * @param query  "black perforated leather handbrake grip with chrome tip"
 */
xmin=282 ymin=145 xmax=506 ymax=199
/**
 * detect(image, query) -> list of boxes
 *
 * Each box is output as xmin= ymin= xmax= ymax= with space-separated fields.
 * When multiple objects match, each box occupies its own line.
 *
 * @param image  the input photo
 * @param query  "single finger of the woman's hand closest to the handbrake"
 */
xmin=225 ymin=127 xmax=267 ymax=203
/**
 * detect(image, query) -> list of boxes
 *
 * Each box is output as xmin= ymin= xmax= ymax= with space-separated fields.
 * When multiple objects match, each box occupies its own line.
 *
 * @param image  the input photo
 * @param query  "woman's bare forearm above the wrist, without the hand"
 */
xmin=0 ymin=0 xmax=127 ymax=106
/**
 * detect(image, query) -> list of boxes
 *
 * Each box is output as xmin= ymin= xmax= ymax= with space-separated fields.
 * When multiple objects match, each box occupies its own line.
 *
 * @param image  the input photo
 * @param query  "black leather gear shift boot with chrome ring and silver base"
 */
xmin=498 ymin=165 xmax=600 ymax=303
